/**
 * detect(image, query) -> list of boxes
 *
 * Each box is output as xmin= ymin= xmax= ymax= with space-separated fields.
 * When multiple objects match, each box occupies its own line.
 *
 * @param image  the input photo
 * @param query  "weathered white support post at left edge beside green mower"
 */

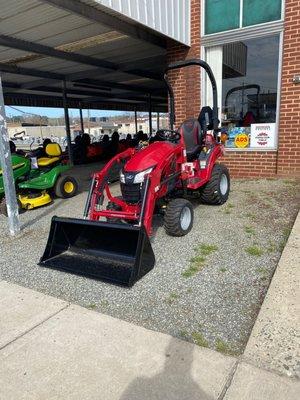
xmin=0 ymin=76 xmax=20 ymax=236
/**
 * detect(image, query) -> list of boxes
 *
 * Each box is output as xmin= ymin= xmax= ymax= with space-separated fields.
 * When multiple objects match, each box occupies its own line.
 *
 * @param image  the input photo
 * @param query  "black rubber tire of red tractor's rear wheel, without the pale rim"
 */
xmin=200 ymin=164 xmax=230 ymax=205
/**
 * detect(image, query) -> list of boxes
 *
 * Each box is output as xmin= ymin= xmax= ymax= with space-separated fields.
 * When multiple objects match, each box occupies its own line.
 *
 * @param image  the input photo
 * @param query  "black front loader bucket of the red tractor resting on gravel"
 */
xmin=39 ymin=217 xmax=155 ymax=286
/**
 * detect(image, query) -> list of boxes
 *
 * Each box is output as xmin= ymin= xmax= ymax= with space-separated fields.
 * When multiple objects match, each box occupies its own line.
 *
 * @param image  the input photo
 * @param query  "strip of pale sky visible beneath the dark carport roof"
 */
xmin=5 ymin=106 xmax=124 ymax=118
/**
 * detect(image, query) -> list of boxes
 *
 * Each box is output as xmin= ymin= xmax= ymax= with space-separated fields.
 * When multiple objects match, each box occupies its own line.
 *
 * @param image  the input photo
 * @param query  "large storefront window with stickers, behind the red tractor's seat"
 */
xmin=206 ymin=35 xmax=279 ymax=149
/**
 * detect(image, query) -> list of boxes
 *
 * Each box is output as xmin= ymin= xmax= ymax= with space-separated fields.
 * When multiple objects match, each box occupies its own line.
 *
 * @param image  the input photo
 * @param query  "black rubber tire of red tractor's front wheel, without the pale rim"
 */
xmin=164 ymin=199 xmax=194 ymax=236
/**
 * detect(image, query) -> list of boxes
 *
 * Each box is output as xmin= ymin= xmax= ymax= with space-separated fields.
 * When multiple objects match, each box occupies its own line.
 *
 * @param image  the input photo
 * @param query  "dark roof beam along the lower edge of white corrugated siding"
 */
xmin=41 ymin=0 xmax=166 ymax=48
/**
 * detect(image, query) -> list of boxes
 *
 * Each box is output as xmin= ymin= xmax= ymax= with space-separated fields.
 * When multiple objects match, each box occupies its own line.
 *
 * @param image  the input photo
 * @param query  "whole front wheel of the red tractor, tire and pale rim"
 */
xmin=164 ymin=199 xmax=194 ymax=236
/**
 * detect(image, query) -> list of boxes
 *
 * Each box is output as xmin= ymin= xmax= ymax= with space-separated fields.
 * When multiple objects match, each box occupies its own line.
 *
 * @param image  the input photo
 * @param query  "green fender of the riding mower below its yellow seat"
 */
xmin=19 ymin=165 xmax=70 ymax=190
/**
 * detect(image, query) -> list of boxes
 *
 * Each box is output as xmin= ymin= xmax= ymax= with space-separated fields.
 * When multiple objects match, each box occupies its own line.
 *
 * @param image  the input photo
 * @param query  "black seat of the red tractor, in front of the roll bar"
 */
xmin=179 ymin=118 xmax=203 ymax=161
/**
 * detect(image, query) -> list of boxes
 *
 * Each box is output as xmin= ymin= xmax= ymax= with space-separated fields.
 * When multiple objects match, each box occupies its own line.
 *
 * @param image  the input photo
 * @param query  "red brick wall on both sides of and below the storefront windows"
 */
xmin=168 ymin=0 xmax=300 ymax=177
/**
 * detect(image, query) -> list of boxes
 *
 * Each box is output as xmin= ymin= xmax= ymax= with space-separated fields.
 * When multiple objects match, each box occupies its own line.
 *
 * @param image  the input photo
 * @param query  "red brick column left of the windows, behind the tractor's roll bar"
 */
xmin=168 ymin=0 xmax=201 ymax=126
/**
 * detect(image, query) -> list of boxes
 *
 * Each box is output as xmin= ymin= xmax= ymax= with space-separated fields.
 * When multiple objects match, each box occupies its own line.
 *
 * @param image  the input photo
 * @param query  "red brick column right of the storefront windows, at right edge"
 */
xmin=277 ymin=0 xmax=300 ymax=176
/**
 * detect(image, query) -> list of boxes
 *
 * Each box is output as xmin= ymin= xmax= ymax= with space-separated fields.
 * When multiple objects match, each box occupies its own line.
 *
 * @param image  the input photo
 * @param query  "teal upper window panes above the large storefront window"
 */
xmin=205 ymin=0 xmax=282 ymax=35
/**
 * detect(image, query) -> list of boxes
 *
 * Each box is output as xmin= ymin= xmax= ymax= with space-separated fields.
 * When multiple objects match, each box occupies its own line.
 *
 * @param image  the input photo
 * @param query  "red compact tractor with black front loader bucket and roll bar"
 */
xmin=39 ymin=60 xmax=230 ymax=286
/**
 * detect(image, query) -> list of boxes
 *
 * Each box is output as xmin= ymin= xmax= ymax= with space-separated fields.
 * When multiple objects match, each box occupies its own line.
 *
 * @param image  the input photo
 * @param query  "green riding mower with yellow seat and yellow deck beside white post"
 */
xmin=0 ymin=143 xmax=78 ymax=215
